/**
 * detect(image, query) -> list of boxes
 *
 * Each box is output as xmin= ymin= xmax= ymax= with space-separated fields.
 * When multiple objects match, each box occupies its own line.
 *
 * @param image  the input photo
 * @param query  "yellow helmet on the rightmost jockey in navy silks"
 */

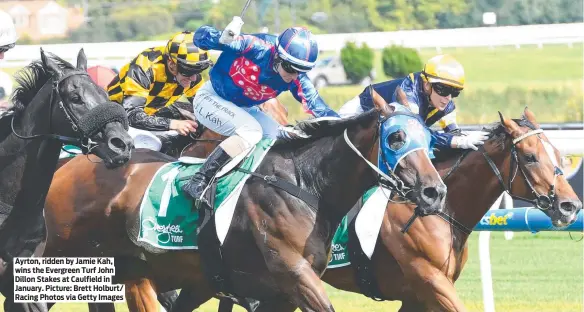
xmin=423 ymin=54 xmax=464 ymax=89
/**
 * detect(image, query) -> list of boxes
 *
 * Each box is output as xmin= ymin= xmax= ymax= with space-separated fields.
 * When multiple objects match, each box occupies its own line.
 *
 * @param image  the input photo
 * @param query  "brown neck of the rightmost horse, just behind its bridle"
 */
xmin=446 ymin=147 xmax=510 ymax=239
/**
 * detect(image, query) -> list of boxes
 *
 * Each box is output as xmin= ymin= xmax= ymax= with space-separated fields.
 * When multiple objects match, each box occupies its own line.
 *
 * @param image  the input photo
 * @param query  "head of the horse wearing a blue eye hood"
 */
xmin=371 ymin=88 xmax=446 ymax=214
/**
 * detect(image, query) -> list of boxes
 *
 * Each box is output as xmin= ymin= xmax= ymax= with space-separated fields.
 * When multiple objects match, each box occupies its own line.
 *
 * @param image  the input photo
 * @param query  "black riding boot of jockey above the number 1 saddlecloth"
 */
xmin=182 ymin=146 xmax=232 ymax=204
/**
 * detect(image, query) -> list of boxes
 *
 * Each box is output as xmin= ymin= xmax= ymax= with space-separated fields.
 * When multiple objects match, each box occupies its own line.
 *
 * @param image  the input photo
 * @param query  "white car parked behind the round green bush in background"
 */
xmin=307 ymin=55 xmax=375 ymax=89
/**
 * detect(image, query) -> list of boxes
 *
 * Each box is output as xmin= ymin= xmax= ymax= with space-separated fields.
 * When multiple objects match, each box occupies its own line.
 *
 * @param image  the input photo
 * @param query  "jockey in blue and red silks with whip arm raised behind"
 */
xmin=182 ymin=16 xmax=339 ymax=200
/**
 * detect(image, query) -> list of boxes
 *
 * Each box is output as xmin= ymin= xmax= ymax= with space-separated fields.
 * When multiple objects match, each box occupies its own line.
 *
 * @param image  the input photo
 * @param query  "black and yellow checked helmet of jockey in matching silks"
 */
xmin=165 ymin=31 xmax=209 ymax=65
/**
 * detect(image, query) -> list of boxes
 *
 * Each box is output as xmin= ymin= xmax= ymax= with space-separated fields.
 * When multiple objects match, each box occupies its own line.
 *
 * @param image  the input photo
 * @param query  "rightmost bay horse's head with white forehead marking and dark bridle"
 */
xmin=499 ymin=107 xmax=582 ymax=227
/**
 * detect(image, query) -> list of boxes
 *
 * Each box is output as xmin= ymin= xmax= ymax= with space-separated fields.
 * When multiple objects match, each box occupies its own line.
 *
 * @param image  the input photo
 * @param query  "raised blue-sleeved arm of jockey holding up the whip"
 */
xmin=193 ymin=26 xmax=254 ymax=53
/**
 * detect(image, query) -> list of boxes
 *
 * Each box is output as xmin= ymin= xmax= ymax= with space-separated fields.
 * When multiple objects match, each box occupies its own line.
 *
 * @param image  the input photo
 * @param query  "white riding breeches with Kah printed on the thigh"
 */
xmin=193 ymin=81 xmax=280 ymax=149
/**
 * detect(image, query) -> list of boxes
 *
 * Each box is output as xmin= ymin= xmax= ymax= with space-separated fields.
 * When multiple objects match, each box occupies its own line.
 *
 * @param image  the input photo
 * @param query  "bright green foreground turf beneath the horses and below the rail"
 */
xmin=3 ymin=232 xmax=584 ymax=312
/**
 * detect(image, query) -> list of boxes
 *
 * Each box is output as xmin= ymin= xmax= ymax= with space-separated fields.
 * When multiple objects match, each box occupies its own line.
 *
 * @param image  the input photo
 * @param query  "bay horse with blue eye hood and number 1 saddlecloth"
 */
xmin=43 ymin=89 xmax=446 ymax=311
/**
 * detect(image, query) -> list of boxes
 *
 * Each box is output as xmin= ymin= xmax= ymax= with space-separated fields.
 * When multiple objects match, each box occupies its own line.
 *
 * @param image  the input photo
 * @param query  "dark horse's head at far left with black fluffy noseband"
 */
xmin=41 ymin=49 xmax=133 ymax=168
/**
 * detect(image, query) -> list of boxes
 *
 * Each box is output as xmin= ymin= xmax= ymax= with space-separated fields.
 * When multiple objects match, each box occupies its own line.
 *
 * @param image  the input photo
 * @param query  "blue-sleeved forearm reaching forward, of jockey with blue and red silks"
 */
xmin=290 ymin=73 xmax=340 ymax=118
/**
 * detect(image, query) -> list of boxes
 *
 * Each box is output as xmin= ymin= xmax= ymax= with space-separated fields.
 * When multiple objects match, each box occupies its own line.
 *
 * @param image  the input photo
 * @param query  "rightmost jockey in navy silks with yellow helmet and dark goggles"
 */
xmin=339 ymin=55 xmax=486 ymax=150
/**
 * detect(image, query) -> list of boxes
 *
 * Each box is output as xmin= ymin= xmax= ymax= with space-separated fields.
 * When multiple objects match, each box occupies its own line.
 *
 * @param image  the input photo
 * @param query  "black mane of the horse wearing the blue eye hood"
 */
xmin=274 ymin=109 xmax=379 ymax=147
